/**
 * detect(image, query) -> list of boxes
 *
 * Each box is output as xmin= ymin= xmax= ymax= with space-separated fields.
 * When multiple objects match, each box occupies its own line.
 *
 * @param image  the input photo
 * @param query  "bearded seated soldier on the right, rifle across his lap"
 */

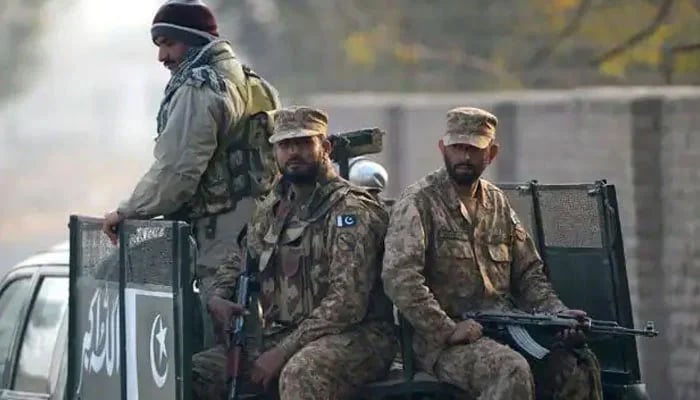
xmin=382 ymin=107 xmax=602 ymax=399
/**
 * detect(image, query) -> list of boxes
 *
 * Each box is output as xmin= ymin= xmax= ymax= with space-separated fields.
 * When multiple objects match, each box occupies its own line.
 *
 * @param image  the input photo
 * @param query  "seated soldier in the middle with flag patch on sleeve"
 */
xmin=193 ymin=107 xmax=397 ymax=400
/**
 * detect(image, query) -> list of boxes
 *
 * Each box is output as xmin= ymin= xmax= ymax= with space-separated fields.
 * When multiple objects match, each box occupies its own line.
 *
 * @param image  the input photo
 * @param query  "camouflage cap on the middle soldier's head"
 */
xmin=269 ymin=106 xmax=328 ymax=143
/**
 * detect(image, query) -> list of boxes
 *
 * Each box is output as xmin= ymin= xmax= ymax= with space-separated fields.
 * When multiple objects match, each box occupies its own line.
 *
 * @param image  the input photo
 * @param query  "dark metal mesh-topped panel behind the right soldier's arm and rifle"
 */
xmin=503 ymin=181 xmax=640 ymax=384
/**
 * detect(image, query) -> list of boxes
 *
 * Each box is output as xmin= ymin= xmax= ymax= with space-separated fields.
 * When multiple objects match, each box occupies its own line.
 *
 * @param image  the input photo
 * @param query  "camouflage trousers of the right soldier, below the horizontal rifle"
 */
xmin=433 ymin=337 xmax=602 ymax=400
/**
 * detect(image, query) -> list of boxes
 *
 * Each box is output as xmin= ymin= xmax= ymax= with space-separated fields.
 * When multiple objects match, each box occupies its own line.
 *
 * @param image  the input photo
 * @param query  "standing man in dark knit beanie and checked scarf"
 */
xmin=103 ymin=0 xmax=278 ymax=343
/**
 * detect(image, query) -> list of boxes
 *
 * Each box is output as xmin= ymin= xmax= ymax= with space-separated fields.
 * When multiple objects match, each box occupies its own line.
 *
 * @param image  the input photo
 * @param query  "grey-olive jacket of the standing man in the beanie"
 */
xmin=118 ymin=41 xmax=254 ymax=220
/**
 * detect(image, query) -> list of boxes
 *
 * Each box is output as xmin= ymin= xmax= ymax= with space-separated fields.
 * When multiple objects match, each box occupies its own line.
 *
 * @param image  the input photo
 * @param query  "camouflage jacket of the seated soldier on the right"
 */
xmin=382 ymin=168 xmax=565 ymax=369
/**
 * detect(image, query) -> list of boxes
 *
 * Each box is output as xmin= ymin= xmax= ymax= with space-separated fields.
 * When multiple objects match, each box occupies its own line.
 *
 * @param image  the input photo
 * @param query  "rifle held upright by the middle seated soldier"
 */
xmin=224 ymin=250 xmax=259 ymax=400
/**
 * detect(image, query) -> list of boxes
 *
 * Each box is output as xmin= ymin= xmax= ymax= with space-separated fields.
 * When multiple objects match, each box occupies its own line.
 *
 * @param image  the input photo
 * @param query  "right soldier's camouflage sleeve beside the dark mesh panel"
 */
xmin=511 ymin=210 xmax=567 ymax=313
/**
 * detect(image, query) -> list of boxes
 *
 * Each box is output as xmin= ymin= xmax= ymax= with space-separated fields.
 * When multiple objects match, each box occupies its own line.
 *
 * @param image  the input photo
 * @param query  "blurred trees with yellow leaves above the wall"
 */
xmin=211 ymin=0 xmax=700 ymax=93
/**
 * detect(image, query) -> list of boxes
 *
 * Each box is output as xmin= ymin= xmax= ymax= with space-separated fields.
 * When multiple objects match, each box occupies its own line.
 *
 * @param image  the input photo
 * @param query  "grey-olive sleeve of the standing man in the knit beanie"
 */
xmin=118 ymin=85 xmax=241 ymax=219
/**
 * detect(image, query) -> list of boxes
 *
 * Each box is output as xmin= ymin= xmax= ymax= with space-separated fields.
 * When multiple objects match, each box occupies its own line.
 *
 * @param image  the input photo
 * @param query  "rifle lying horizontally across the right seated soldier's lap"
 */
xmin=461 ymin=311 xmax=659 ymax=360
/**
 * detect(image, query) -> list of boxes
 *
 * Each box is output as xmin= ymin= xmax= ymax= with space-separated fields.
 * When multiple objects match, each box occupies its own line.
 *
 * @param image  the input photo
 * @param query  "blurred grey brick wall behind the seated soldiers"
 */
xmin=305 ymin=87 xmax=700 ymax=399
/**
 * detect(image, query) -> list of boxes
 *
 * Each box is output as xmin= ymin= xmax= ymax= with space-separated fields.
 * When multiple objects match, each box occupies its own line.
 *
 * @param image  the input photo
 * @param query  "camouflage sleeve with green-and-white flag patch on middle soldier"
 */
xmin=278 ymin=200 xmax=388 ymax=358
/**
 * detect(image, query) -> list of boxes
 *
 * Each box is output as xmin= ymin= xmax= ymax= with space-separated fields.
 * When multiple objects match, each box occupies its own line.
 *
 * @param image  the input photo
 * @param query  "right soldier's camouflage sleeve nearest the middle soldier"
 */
xmin=382 ymin=197 xmax=456 ymax=343
